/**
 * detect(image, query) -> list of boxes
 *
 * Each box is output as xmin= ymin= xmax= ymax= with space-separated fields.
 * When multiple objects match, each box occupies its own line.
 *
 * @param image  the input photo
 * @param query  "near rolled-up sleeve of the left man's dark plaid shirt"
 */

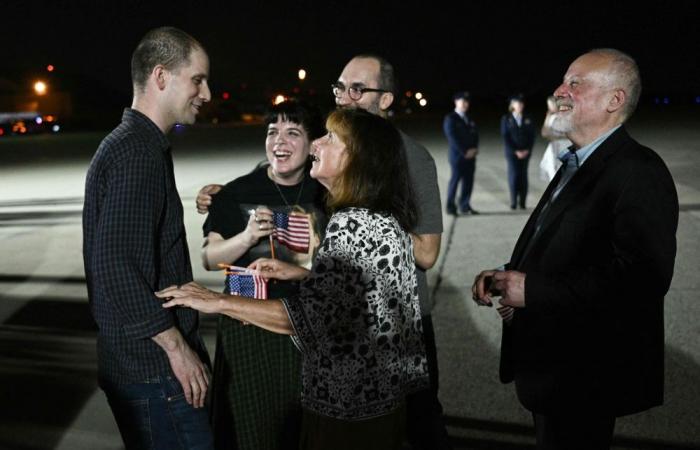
xmin=91 ymin=149 xmax=175 ymax=340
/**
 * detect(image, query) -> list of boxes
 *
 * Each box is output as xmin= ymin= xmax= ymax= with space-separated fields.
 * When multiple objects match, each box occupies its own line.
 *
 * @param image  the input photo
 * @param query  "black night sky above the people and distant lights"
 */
xmin=0 ymin=0 xmax=700 ymax=116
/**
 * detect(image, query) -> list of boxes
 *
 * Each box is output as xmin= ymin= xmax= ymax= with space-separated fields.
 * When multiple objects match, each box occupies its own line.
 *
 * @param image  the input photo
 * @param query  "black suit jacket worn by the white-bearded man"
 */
xmin=501 ymin=127 xmax=678 ymax=416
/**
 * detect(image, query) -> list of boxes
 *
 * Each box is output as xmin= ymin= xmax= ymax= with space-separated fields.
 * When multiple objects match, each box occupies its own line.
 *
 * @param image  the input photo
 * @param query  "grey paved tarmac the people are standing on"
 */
xmin=0 ymin=108 xmax=700 ymax=450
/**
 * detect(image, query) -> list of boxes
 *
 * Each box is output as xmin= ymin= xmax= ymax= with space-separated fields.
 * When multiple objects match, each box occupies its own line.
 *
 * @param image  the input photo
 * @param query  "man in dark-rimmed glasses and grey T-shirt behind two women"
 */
xmin=332 ymin=54 xmax=452 ymax=449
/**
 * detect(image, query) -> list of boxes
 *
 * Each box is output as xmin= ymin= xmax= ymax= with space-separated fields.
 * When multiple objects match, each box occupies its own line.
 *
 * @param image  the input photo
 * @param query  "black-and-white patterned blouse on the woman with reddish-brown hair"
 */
xmin=283 ymin=208 xmax=428 ymax=420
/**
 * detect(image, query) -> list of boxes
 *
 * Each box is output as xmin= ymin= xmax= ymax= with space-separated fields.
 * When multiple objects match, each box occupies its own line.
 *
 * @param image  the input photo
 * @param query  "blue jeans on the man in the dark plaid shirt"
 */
xmin=102 ymin=376 xmax=214 ymax=450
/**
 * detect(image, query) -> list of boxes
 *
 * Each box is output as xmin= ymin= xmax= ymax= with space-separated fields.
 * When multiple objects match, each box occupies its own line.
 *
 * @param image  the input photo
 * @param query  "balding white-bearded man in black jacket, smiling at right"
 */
xmin=472 ymin=49 xmax=678 ymax=450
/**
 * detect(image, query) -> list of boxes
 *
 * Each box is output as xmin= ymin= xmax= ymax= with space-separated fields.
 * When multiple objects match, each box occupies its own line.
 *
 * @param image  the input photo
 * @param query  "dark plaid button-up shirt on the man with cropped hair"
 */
xmin=83 ymin=108 xmax=208 ymax=384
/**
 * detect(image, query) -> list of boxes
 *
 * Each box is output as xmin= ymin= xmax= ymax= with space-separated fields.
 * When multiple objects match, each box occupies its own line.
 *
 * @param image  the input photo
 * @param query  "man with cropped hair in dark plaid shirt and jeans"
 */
xmin=83 ymin=28 xmax=212 ymax=449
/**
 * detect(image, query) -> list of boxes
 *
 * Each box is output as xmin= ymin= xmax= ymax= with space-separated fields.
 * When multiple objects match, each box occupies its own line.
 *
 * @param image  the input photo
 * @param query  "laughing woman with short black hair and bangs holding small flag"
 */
xmin=202 ymin=101 xmax=327 ymax=450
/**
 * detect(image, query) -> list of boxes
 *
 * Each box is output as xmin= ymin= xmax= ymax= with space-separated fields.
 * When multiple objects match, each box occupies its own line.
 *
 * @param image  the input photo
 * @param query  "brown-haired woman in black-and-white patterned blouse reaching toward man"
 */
xmin=158 ymin=110 xmax=427 ymax=449
